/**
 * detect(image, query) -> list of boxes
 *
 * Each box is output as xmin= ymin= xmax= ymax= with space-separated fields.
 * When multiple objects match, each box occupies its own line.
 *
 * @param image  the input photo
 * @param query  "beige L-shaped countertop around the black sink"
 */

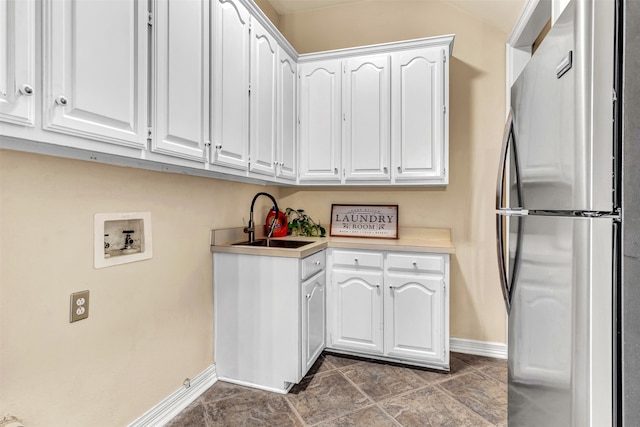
xmin=211 ymin=227 xmax=455 ymax=258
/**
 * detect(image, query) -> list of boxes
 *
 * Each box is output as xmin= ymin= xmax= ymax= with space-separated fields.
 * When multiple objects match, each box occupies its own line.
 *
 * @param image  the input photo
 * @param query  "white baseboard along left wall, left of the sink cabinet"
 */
xmin=129 ymin=364 xmax=218 ymax=427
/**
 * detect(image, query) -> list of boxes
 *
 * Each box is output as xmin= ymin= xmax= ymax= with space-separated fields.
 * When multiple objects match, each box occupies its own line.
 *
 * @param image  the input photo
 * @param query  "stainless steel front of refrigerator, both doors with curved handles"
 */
xmin=496 ymin=0 xmax=624 ymax=427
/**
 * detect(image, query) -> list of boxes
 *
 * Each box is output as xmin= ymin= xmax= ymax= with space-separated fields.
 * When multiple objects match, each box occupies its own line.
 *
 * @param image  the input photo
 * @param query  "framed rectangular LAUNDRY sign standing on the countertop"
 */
xmin=330 ymin=205 xmax=398 ymax=239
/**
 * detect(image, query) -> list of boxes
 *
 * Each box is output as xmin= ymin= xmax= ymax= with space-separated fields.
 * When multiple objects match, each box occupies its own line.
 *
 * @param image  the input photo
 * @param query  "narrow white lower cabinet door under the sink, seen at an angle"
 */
xmin=301 ymin=272 xmax=326 ymax=376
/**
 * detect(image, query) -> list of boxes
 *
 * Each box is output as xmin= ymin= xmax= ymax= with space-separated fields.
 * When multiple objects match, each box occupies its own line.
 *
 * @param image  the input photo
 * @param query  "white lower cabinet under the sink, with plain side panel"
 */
xmin=213 ymin=251 xmax=326 ymax=393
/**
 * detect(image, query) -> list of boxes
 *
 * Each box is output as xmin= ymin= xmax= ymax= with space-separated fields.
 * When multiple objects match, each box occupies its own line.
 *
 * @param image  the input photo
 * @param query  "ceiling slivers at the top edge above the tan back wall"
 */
xmin=268 ymin=0 xmax=526 ymax=34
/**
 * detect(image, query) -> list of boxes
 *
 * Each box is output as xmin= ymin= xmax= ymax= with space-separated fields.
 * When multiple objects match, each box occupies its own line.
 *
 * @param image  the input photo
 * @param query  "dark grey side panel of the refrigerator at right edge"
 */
xmin=615 ymin=0 xmax=640 ymax=427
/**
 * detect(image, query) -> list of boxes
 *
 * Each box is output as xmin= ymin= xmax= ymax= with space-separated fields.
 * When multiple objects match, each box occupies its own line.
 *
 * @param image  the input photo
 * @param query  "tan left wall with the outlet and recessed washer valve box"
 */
xmin=0 ymin=151 xmax=277 ymax=427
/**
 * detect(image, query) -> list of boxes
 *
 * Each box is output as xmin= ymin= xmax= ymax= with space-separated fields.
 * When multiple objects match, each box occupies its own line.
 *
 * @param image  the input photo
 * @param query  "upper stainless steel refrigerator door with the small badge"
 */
xmin=511 ymin=1 xmax=613 ymax=212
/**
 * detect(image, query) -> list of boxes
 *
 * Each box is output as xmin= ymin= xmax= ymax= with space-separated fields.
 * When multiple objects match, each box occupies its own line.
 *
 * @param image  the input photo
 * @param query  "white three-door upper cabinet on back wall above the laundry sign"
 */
xmin=299 ymin=35 xmax=454 ymax=185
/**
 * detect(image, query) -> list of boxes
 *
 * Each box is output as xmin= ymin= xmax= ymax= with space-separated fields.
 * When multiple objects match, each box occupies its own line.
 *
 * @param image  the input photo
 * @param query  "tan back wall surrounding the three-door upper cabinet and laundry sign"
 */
xmin=280 ymin=1 xmax=507 ymax=343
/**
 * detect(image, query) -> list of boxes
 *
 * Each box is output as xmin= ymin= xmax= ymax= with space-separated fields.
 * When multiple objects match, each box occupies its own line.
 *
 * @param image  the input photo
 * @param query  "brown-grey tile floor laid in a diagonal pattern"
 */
xmin=167 ymin=353 xmax=507 ymax=427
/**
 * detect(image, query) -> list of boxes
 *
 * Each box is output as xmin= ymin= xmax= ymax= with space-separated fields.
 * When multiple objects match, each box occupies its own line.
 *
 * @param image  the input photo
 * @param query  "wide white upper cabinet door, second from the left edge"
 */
xmin=43 ymin=0 xmax=148 ymax=148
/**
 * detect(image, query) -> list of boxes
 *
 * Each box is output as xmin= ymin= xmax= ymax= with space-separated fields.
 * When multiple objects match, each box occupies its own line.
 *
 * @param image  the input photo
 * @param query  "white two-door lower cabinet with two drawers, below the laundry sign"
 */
xmin=327 ymin=249 xmax=449 ymax=369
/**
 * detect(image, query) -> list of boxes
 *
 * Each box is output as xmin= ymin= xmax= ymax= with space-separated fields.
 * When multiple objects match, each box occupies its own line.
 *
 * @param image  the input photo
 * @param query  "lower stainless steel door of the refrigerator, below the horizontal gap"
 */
xmin=508 ymin=216 xmax=613 ymax=427
